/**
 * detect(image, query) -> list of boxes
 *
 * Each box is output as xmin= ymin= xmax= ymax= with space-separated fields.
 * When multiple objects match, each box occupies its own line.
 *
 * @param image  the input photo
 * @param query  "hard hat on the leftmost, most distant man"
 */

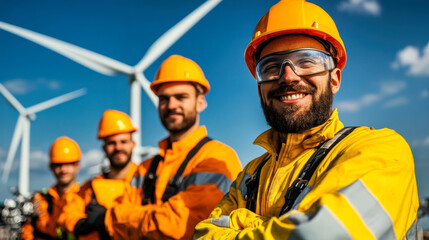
xmin=49 ymin=137 xmax=82 ymax=163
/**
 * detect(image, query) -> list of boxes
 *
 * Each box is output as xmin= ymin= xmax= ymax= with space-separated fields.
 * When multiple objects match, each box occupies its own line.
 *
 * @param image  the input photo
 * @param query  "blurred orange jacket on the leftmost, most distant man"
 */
xmin=21 ymin=184 xmax=79 ymax=240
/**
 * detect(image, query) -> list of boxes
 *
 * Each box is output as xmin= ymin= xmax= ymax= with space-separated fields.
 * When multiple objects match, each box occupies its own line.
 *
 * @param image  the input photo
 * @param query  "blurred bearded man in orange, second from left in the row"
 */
xmin=61 ymin=110 xmax=137 ymax=239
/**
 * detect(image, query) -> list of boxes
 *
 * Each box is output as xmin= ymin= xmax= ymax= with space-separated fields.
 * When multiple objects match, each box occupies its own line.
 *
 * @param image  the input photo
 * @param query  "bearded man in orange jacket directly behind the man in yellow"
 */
xmin=106 ymin=55 xmax=241 ymax=239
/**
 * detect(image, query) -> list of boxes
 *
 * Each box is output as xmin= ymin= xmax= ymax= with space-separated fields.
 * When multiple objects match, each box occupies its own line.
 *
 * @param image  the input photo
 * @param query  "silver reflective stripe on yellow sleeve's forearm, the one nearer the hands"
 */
xmin=287 ymin=206 xmax=352 ymax=240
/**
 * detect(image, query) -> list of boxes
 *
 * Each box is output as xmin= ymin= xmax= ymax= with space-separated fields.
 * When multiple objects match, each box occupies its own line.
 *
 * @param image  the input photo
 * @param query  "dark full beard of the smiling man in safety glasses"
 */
xmin=261 ymin=75 xmax=334 ymax=133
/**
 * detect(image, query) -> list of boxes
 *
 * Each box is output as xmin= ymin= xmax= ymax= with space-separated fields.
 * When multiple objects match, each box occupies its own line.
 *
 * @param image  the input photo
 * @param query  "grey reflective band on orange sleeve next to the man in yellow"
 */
xmin=179 ymin=172 xmax=232 ymax=194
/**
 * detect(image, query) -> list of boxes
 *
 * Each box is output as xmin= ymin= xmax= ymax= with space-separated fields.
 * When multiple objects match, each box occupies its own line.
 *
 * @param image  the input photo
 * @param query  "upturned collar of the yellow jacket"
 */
xmin=253 ymin=109 xmax=344 ymax=156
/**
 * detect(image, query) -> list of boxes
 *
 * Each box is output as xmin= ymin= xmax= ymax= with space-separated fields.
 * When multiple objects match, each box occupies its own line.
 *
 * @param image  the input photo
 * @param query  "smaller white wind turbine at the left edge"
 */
xmin=0 ymin=83 xmax=86 ymax=195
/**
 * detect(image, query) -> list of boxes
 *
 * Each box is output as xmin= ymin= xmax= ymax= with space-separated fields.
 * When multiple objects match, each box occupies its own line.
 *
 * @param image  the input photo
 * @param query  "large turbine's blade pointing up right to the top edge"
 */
xmin=135 ymin=0 xmax=222 ymax=72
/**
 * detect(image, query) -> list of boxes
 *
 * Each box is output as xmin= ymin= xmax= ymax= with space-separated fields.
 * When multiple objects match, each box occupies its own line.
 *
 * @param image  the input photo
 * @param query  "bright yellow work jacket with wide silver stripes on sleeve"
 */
xmin=194 ymin=110 xmax=419 ymax=239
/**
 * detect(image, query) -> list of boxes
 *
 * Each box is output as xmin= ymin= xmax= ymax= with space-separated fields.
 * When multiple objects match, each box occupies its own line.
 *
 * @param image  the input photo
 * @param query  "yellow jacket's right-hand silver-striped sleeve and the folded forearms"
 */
xmin=194 ymin=130 xmax=419 ymax=239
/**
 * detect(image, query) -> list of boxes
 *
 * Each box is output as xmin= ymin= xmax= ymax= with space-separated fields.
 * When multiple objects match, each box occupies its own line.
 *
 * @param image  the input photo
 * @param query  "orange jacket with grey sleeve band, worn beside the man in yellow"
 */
xmin=106 ymin=126 xmax=241 ymax=239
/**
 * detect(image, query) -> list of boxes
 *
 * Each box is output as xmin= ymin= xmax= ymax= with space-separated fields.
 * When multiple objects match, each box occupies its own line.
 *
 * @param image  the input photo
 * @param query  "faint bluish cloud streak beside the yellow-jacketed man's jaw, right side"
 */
xmin=335 ymin=81 xmax=408 ymax=112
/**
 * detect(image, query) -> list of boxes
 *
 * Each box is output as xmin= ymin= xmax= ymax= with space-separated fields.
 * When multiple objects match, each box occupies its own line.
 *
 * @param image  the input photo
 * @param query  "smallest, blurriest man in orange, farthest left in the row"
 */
xmin=21 ymin=137 xmax=81 ymax=239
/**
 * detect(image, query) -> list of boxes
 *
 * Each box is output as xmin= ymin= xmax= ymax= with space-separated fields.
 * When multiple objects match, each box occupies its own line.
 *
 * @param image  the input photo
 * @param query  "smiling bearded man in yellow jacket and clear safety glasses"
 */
xmin=194 ymin=0 xmax=419 ymax=239
